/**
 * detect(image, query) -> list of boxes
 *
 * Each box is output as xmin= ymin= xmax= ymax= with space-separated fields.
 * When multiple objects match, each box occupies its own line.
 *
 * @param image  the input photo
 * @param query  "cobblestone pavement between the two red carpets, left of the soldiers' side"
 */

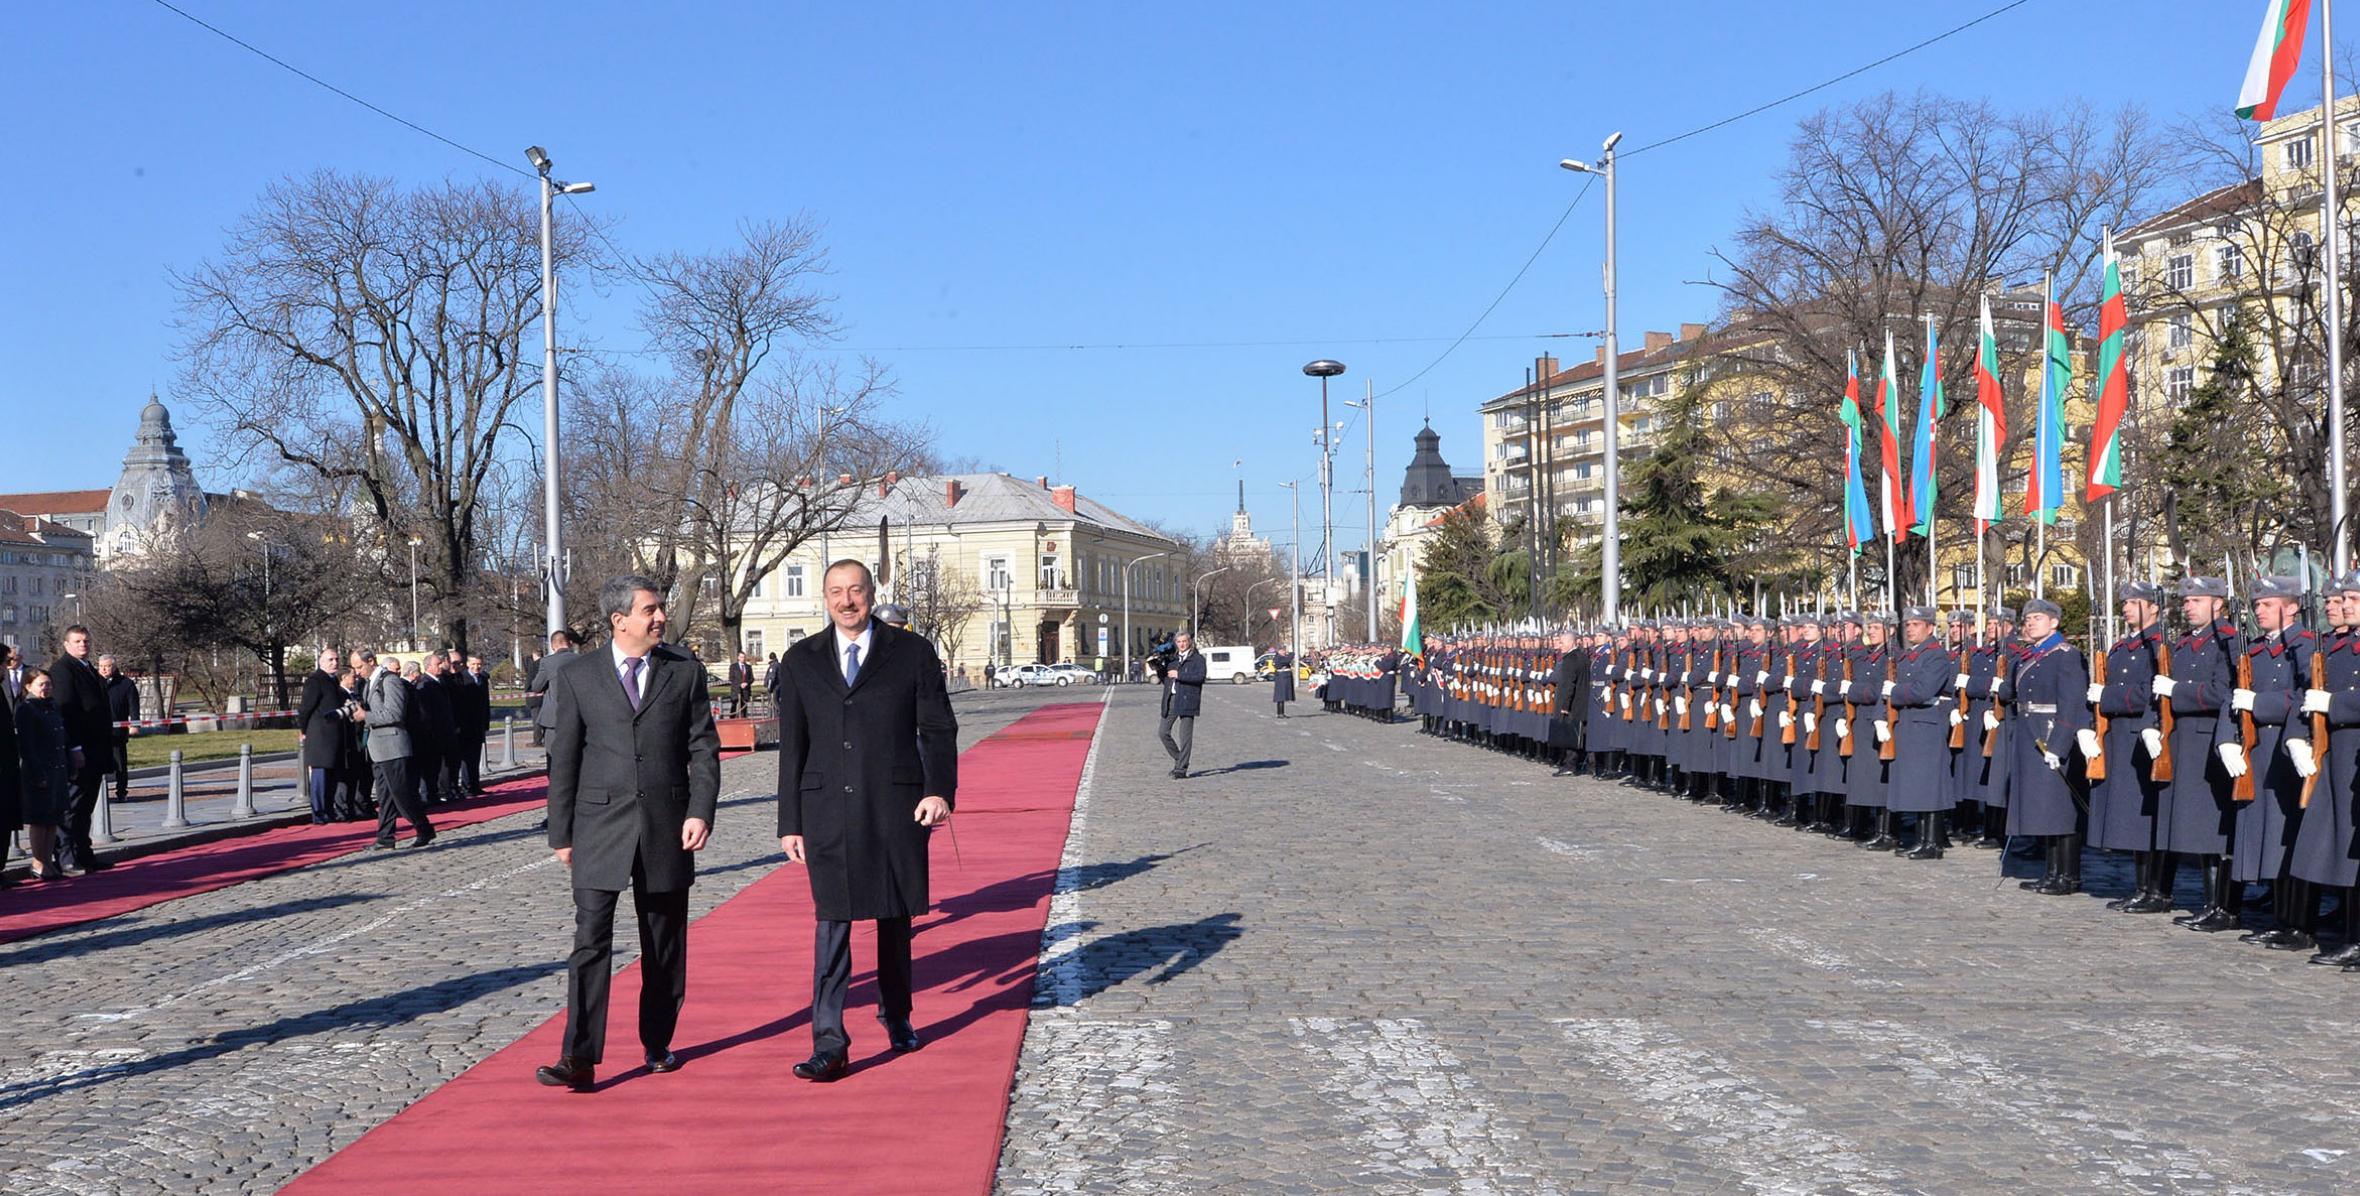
xmin=0 ymin=691 xmax=1076 ymax=1196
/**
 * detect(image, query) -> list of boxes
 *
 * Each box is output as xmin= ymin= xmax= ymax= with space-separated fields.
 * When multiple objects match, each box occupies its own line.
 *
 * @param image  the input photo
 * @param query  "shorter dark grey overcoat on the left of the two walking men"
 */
xmin=540 ymin=644 xmax=722 ymax=892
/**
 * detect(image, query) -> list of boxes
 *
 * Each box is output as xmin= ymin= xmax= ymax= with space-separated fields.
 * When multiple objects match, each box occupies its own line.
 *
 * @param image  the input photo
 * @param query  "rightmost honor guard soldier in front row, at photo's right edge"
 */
xmin=2287 ymin=573 xmax=2360 ymax=972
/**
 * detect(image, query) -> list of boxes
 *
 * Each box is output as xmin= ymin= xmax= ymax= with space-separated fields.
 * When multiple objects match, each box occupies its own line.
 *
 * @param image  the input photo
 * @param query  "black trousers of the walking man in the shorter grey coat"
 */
xmin=559 ymin=866 xmax=689 ymax=1064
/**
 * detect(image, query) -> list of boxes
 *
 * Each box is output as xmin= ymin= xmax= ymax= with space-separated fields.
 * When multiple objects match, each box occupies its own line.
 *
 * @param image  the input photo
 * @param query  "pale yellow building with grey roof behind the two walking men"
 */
xmin=706 ymin=474 xmax=1189 ymax=677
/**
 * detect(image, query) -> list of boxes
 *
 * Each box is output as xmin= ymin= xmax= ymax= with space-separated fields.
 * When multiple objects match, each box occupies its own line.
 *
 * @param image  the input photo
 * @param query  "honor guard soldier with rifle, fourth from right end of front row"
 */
xmin=2089 ymin=583 xmax=2174 ymax=913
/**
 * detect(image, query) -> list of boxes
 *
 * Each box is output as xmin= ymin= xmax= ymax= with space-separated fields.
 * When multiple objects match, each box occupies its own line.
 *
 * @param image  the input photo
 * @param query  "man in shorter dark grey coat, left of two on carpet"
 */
xmin=536 ymin=576 xmax=722 ymax=1092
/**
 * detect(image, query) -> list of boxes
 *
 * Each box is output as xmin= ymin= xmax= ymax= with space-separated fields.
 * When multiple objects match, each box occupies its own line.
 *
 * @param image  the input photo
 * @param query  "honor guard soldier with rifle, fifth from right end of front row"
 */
xmin=2006 ymin=599 xmax=2091 ymax=896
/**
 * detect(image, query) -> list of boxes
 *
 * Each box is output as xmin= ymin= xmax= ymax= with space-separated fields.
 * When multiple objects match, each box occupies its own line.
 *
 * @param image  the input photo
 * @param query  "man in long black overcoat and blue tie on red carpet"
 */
xmin=772 ymin=559 xmax=958 ymax=1080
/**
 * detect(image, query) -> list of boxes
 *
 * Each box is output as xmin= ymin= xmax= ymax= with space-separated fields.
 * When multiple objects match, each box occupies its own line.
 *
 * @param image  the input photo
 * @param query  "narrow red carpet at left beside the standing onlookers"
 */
xmin=0 ymin=753 xmax=746 ymax=944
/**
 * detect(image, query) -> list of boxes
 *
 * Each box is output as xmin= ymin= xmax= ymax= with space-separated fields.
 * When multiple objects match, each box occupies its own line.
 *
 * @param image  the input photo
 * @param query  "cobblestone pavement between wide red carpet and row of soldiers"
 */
xmin=998 ymin=686 xmax=2360 ymax=1196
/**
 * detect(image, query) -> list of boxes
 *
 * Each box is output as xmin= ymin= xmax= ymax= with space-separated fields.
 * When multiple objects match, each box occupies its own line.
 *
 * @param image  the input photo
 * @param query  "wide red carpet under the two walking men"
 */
xmin=283 ymin=701 xmax=1100 ymax=1196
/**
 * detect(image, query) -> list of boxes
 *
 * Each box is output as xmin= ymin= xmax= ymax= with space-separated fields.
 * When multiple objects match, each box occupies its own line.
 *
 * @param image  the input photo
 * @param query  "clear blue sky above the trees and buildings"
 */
xmin=0 ymin=0 xmax=2318 ymax=561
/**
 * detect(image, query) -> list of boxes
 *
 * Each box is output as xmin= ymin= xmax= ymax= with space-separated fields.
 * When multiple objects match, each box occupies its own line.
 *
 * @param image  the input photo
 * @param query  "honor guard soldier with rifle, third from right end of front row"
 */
xmin=2155 ymin=576 xmax=2244 ymax=932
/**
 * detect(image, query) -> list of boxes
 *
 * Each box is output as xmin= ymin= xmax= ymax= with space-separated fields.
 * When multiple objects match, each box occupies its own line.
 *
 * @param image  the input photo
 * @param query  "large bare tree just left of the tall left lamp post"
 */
xmin=175 ymin=172 xmax=597 ymax=644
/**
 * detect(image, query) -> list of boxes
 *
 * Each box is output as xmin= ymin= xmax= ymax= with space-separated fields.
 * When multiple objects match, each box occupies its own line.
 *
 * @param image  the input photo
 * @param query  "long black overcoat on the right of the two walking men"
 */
xmin=772 ymin=623 xmax=958 ymax=922
